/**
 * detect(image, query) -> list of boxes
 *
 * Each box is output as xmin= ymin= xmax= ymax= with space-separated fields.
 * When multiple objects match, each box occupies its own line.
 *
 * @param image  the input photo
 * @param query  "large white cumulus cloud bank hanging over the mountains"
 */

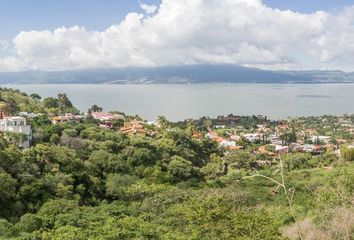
xmin=0 ymin=0 xmax=354 ymax=71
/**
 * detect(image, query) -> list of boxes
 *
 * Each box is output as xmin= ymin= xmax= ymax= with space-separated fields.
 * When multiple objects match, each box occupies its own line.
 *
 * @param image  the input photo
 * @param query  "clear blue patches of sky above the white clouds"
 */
xmin=0 ymin=0 xmax=354 ymax=39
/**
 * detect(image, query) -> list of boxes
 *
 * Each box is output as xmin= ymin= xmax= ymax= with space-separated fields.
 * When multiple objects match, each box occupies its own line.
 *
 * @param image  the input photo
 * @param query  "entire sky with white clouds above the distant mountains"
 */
xmin=0 ymin=0 xmax=354 ymax=71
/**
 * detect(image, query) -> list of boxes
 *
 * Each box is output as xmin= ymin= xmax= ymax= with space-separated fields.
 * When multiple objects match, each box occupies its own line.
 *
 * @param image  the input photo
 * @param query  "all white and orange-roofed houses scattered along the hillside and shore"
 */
xmin=0 ymin=111 xmax=354 ymax=155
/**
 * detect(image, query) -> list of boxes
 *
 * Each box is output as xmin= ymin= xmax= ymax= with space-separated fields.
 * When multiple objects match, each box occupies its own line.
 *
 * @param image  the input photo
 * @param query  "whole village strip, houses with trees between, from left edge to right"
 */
xmin=0 ymin=111 xmax=354 ymax=163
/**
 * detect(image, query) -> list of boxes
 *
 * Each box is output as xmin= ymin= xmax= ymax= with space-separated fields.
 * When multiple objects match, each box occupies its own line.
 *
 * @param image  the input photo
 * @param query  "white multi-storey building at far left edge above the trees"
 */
xmin=0 ymin=116 xmax=32 ymax=148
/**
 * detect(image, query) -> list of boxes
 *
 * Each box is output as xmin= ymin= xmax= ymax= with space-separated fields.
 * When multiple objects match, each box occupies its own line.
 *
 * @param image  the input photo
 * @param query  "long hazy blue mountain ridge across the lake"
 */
xmin=0 ymin=65 xmax=354 ymax=84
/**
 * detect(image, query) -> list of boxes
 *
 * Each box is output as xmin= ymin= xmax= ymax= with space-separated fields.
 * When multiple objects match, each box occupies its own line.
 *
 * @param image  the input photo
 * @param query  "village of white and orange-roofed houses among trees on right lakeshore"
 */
xmin=193 ymin=114 xmax=354 ymax=157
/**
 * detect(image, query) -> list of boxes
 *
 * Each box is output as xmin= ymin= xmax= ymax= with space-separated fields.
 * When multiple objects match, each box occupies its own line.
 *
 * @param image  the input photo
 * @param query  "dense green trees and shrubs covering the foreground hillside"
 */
xmin=0 ymin=89 xmax=354 ymax=240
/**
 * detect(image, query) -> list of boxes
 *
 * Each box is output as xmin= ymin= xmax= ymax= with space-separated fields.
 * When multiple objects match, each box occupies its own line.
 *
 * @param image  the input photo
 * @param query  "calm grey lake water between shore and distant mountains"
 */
xmin=3 ymin=84 xmax=354 ymax=121
